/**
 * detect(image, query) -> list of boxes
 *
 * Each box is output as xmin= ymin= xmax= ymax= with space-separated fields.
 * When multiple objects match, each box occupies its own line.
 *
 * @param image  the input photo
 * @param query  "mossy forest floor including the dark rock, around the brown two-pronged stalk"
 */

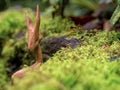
xmin=0 ymin=2 xmax=120 ymax=90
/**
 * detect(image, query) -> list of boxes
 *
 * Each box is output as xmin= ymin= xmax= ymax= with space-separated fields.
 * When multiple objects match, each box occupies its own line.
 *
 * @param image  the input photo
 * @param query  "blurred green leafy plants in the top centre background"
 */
xmin=42 ymin=0 xmax=112 ymax=17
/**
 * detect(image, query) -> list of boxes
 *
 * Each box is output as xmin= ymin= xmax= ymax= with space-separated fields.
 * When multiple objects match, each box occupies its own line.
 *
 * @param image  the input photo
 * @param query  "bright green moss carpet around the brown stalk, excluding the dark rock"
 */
xmin=0 ymin=10 xmax=120 ymax=90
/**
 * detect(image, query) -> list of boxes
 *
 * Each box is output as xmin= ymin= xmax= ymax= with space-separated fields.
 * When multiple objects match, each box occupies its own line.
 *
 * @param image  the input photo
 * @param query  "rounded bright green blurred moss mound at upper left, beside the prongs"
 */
xmin=0 ymin=10 xmax=25 ymax=37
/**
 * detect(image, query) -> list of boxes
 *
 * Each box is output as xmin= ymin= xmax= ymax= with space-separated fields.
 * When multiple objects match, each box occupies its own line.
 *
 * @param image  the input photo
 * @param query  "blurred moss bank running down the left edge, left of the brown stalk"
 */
xmin=0 ymin=10 xmax=25 ymax=90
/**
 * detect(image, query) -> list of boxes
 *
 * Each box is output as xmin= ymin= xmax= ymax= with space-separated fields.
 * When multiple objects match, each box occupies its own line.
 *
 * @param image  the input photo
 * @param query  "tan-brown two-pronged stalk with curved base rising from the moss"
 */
xmin=12 ymin=5 xmax=43 ymax=79
